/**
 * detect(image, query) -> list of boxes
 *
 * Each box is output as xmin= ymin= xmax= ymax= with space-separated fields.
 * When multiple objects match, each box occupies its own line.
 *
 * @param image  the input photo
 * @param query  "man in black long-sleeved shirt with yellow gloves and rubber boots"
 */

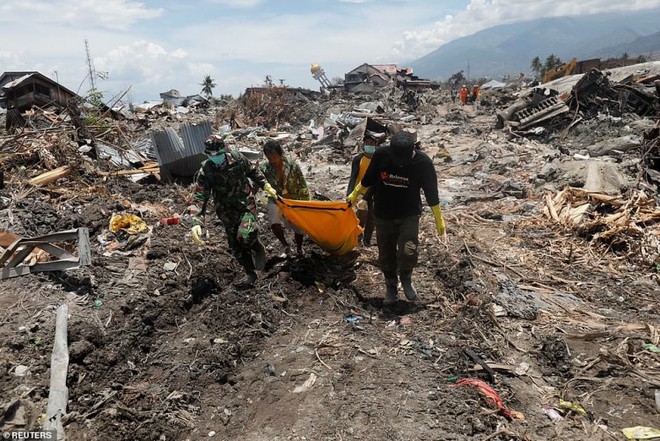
xmin=348 ymin=132 xmax=445 ymax=306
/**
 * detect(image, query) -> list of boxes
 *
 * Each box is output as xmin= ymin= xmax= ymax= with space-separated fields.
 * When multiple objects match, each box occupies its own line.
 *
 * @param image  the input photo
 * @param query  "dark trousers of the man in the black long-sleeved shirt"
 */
xmin=375 ymin=216 xmax=420 ymax=279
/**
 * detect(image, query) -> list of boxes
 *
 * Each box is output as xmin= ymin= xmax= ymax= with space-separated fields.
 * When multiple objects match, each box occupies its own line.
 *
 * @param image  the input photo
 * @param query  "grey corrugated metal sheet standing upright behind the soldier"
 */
xmin=150 ymin=121 xmax=213 ymax=177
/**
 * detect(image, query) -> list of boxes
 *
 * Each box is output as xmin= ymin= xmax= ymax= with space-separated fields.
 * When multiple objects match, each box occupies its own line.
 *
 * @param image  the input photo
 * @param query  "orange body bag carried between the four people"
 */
xmin=276 ymin=198 xmax=362 ymax=256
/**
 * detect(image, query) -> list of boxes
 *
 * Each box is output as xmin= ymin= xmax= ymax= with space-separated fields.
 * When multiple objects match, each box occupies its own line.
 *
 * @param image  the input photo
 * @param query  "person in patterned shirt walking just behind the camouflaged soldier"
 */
xmin=260 ymin=139 xmax=309 ymax=257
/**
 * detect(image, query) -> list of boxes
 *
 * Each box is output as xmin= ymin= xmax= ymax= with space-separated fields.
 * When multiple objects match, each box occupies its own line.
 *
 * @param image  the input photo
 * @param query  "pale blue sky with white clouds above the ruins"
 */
xmin=0 ymin=0 xmax=660 ymax=103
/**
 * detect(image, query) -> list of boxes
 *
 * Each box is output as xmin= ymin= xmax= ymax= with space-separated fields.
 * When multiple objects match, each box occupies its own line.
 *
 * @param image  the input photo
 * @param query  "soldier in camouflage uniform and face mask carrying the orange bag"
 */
xmin=192 ymin=135 xmax=277 ymax=286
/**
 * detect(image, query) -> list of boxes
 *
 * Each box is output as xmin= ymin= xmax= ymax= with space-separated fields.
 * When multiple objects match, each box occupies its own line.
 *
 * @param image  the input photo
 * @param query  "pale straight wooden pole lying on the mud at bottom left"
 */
xmin=43 ymin=303 xmax=69 ymax=441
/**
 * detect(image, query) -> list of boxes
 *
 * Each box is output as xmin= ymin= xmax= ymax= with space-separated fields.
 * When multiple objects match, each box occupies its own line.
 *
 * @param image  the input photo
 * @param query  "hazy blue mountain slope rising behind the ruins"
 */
xmin=406 ymin=8 xmax=660 ymax=80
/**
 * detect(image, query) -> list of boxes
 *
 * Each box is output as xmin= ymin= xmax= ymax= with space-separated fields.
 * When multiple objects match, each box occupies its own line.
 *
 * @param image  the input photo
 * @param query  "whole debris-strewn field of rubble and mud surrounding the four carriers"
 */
xmin=0 ymin=62 xmax=660 ymax=440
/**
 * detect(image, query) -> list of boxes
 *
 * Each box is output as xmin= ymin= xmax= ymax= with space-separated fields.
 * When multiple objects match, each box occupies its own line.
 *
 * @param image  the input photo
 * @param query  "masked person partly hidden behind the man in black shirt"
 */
xmin=346 ymin=132 xmax=379 ymax=247
